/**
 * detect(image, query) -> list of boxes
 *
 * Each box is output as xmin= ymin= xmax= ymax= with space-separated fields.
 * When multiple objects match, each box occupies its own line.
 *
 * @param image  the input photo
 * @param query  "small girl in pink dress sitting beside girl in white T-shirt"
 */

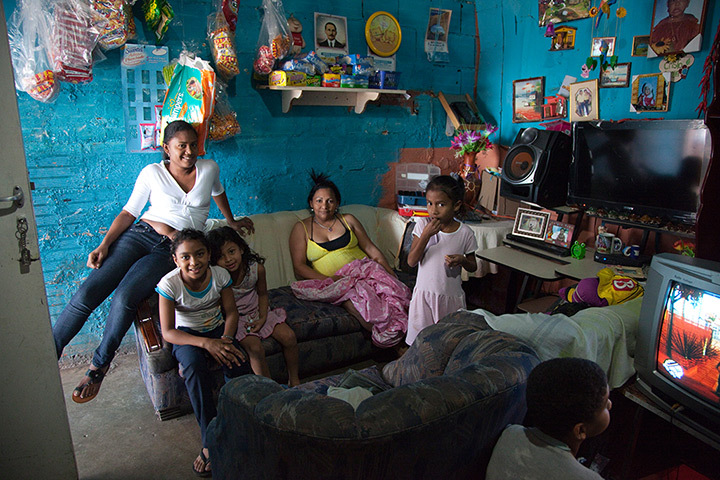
xmin=208 ymin=227 xmax=300 ymax=387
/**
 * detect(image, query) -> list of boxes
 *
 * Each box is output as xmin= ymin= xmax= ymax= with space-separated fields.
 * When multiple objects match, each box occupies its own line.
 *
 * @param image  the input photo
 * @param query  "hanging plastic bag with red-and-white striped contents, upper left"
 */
xmin=52 ymin=0 xmax=107 ymax=83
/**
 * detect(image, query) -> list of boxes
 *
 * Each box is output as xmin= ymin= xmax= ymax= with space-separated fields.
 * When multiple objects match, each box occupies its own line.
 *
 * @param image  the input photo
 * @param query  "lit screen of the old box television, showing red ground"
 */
xmin=655 ymin=281 xmax=720 ymax=406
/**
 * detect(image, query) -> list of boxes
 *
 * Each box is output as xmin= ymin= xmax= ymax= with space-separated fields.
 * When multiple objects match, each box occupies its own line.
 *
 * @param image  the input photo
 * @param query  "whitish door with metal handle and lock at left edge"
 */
xmin=0 ymin=2 xmax=78 ymax=479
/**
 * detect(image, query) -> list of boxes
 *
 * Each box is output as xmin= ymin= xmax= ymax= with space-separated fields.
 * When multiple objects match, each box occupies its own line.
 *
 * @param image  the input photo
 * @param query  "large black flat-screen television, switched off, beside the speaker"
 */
xmin=568 ymin=120 xmax=711 ymax=224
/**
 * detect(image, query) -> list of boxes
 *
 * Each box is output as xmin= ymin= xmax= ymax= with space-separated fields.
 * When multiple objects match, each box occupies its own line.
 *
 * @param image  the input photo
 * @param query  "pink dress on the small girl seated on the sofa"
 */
xmin=232 ymin=263 xmax=287 ymax=341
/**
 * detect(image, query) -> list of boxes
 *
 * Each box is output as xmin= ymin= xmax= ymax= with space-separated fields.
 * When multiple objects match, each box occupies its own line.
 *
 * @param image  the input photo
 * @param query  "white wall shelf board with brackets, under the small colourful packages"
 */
xmin=257 ymin=85 xmax=407 ymax=113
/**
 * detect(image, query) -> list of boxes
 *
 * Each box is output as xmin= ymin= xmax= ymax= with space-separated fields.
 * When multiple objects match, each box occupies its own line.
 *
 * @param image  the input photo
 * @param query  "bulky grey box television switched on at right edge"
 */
xmin=635 ymin=253 xmax=720 ymax=443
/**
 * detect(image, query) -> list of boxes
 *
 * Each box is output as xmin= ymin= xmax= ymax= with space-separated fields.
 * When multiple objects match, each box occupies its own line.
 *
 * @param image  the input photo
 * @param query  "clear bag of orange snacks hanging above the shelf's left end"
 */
xmin=253 ymin=0 xmax=292 ymax=75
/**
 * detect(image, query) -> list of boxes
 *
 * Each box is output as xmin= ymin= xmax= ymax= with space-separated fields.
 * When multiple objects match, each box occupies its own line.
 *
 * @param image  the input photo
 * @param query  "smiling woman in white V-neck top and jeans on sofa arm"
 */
xmin=53 ymin=120 xmax=253 ymax=403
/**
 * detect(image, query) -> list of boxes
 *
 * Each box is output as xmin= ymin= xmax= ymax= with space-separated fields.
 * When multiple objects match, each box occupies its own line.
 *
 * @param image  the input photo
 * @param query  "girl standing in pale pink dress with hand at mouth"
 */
xmin=405 ymin=175 xmax=477 ymax=345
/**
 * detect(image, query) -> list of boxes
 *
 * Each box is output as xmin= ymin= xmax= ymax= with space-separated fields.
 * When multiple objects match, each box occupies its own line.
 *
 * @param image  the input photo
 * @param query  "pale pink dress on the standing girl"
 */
xmin=405 ymin=217 xmax=477 ymax=345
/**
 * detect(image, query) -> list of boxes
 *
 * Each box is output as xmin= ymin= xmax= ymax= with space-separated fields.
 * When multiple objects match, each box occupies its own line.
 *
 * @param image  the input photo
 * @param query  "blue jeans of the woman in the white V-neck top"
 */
xmin=53 ymin=222 xmax=175 ymax=368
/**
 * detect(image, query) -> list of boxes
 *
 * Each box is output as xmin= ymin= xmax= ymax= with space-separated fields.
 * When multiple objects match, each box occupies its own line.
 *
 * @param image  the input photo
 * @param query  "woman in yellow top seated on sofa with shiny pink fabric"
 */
xmin=290 ymin=172 xmax=410 ymax=348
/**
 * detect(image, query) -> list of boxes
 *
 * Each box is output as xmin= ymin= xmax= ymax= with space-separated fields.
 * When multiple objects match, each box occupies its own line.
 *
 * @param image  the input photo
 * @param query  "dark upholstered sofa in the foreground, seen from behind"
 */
xmin=207 ymin=311 xmax=539 ymax=480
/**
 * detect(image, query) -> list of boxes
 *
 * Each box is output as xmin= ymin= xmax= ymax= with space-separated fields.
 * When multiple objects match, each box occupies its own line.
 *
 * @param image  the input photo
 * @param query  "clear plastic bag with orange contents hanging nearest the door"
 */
xmin=8 ymin=0 xmax=60 ymax=103
